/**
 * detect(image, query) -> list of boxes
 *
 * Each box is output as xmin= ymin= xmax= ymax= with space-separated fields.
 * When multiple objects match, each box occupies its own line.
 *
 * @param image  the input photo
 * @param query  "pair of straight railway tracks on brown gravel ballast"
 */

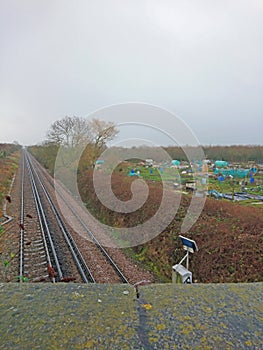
xmin=19 ymin=150 xmax=138 ymax=283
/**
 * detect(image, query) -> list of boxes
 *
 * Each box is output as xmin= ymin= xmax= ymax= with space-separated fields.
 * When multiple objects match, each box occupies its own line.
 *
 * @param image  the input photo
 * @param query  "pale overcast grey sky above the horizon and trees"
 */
xmin=0 ymin=0 xmax=263 ymax=145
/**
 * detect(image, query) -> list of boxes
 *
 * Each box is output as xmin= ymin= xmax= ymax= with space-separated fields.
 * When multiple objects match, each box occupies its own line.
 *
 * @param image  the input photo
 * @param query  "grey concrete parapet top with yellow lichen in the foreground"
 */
xmin=0 ymin=283 xmax=263 ymax=349
